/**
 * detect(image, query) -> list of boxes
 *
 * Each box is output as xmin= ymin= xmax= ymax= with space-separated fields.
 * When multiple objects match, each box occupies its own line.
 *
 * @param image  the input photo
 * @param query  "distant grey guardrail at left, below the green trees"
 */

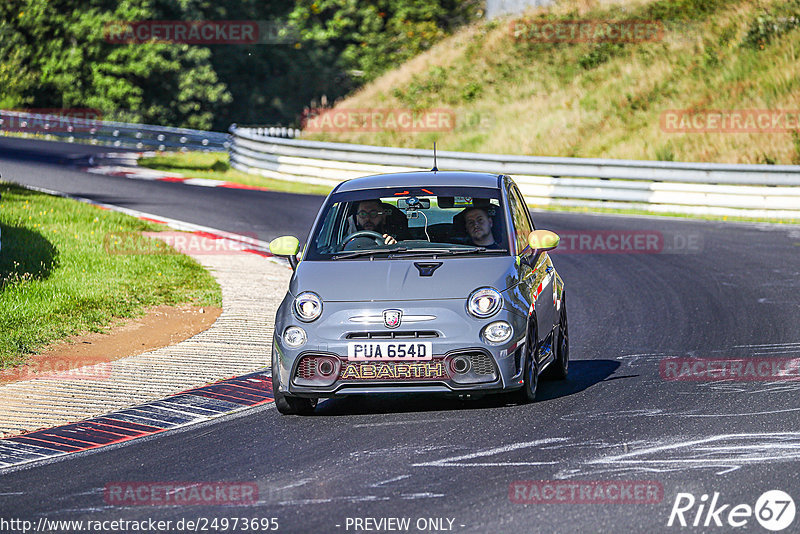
xmin=0 ymin=110 xmax=230 ymax=152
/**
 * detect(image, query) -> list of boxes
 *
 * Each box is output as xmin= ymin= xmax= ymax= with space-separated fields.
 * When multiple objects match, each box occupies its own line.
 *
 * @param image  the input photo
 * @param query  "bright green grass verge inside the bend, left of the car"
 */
xmin=0 ymin=182 xmax=222 ymax=369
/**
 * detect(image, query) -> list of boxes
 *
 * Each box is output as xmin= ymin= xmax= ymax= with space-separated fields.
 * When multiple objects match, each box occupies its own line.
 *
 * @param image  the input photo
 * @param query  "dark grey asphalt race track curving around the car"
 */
xmin=0 ymin=139 xmax=800 ymax=533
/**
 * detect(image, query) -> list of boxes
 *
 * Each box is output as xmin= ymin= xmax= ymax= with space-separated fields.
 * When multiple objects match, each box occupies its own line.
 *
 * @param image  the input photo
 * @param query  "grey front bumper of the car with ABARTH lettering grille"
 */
xmin=272 ymin=298 xmax=527 ymax=397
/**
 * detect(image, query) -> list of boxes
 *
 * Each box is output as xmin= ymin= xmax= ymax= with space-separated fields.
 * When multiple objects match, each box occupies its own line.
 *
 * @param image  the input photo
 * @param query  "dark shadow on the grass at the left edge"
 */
xmin=0 ymin=224 xmax=58 ymax=291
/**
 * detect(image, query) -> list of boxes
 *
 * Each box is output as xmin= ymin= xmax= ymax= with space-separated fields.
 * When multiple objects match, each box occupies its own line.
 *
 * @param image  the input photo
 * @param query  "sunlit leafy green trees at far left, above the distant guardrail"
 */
xmin=0 ymin=0 xmax=231 ymax=128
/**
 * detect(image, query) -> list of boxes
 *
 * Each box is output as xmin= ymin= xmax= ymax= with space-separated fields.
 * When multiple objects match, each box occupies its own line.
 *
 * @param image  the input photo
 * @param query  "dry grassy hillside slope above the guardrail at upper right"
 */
xmin=306 ymin=0 xmax=800 ymax=164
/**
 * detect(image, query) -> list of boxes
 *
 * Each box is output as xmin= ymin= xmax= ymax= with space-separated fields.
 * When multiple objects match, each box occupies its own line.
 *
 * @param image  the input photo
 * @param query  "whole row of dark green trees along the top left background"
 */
xmin=0 ymin=0 xmax=482 ymax=130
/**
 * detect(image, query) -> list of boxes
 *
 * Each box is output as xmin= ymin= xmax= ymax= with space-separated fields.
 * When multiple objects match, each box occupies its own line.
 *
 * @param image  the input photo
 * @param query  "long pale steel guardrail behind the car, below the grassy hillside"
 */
xmin=230 ymin=125 xmax=800 ymax=219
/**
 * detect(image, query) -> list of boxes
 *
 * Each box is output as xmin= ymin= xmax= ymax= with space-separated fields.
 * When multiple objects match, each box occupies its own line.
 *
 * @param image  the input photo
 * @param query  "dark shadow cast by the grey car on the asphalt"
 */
xmin=314 ymin=360 xmax=620 ymax=416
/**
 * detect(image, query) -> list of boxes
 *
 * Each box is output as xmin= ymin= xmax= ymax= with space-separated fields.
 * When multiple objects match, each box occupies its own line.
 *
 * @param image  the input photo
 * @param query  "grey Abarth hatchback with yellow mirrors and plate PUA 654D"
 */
xmin=270 ymin=171 xmax=569 ymax=414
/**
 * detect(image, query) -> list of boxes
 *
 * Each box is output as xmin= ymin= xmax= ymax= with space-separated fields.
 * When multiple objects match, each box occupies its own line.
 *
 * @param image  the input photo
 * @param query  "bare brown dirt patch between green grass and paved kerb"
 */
xmin=0 ymin=306 xmax=222 ymax=384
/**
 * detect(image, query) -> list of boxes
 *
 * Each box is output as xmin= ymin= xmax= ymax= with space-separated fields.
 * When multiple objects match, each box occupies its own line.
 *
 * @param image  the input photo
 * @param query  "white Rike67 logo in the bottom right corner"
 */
xmin=667 ymin=490 xmax=795 ymax=532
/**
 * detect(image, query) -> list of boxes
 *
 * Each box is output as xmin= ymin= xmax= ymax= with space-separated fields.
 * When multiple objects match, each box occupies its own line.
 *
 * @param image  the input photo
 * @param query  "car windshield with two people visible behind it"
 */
xmin=304 ymin=187 xmax=508 ymax=260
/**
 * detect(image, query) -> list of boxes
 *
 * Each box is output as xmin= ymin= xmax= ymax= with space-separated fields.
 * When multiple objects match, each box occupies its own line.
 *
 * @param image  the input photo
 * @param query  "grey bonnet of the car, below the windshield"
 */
xmin=289 ymin=256 xmax=516 ymax=302
